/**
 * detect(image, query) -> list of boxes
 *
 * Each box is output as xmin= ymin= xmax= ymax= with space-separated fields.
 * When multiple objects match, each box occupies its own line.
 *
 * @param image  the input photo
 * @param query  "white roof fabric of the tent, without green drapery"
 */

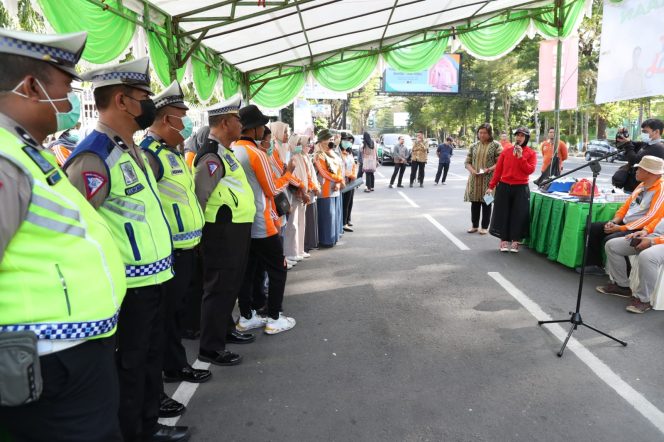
xmin=135 ymin=0 xmax=552 ymax=72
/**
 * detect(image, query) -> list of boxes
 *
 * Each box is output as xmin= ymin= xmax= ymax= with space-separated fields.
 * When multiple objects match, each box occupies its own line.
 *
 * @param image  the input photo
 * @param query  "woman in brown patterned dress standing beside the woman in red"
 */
xmin=463 ymin=123 xmax=502 ymax=235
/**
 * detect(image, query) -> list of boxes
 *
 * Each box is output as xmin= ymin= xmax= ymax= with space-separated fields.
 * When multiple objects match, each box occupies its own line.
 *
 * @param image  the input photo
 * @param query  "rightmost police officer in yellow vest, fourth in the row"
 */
xmin=194 ymin=99 xmax=256 ymax=365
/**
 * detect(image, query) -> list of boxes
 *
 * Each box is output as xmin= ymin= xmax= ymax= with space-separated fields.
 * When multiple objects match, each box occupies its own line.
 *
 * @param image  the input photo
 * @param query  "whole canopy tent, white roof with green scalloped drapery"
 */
xmin=11 ymin=0 xmax=591 ymax=108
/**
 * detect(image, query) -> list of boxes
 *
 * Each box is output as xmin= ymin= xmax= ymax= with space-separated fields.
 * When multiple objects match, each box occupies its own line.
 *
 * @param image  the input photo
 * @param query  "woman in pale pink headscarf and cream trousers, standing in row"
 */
xmin=284 ymin=134 xmax=313 ymax=261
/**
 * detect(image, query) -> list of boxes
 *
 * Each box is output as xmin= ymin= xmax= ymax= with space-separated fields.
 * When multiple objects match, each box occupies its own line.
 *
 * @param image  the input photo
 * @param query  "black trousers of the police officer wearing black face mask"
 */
xmin=116 ymin=285 xmax=164 ymax=442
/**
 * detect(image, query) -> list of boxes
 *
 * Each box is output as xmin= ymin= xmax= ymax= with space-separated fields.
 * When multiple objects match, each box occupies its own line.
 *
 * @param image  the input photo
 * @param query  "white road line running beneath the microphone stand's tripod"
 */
xmin=488 ymin=272 xmax=664 ymax=433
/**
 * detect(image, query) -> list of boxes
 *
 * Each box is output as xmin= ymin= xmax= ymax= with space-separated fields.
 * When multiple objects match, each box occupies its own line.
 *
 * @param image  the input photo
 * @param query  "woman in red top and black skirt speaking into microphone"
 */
xmin=486 ymin=127 xmax=537 ymax=253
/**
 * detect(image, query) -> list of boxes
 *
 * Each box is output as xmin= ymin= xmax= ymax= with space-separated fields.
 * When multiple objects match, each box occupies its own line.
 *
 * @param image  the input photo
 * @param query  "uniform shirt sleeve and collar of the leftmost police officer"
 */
xmin=0 ymin=113 xmax=33 ymax=261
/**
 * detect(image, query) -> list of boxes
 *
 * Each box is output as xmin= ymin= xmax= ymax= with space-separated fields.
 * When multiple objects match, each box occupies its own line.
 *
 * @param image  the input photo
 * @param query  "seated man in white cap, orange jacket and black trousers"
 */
xmin=577 ymin=155 xmax=664 ymax=275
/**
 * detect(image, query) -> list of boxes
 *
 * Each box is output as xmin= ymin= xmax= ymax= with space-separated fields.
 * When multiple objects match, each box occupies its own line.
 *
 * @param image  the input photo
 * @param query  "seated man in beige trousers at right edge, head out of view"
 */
xmin=597 ymin=215 xmax=664 ymax=313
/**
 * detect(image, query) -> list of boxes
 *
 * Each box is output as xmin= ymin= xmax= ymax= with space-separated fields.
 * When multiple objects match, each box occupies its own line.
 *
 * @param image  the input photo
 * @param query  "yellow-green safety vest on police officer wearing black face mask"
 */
xmin=98 ymin=139 xmax=173 ymax=287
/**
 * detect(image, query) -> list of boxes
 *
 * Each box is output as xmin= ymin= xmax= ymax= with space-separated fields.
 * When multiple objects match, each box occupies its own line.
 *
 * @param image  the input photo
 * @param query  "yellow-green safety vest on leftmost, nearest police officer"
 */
xmin=0 ymin=129 xmax=127 ymax=339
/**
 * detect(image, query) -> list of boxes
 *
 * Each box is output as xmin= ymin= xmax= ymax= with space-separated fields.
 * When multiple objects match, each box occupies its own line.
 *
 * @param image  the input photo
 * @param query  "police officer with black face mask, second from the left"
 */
xmin=64 ymin=58 xmax=188 ymax=441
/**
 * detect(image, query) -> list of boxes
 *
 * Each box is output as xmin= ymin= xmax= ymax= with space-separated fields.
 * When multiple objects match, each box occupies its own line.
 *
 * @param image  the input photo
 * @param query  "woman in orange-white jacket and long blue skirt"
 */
xmin=314 ymin=129 xmax=345 ymax=247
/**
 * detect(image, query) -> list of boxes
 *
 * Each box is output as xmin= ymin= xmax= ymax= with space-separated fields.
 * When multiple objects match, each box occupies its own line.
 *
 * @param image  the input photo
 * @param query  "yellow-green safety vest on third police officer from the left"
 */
xmin=141 ymin=137 xmax=205 ymax=249
